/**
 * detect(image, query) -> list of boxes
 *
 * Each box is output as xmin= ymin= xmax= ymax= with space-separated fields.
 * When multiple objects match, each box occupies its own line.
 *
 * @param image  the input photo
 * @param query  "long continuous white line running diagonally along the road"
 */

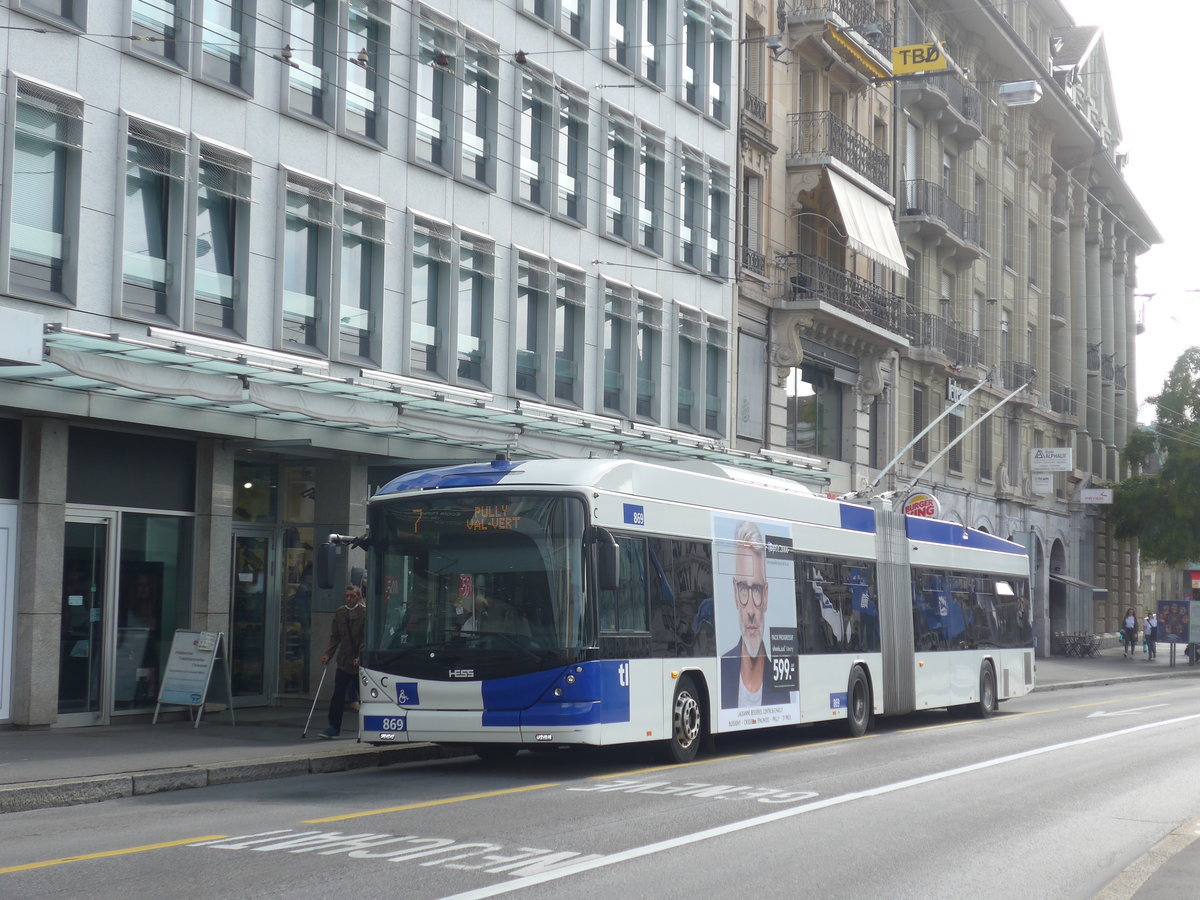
xmin=443 ymin=713 xmax=1200 ymax=900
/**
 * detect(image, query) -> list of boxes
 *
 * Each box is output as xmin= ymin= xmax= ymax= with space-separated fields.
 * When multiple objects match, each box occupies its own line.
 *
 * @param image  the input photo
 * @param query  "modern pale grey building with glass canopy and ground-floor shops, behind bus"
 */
xmin=0 ymin=0 xmax=826 ymax=726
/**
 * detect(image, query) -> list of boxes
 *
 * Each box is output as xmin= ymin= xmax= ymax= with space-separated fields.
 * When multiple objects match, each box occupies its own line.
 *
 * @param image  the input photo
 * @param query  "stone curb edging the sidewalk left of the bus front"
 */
xmin=0 ymin=744 xmax=467 ymax=815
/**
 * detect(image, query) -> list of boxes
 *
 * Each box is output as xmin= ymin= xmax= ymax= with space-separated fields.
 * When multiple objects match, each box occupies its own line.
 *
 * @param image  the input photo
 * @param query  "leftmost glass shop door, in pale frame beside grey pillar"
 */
xmin=58 ymin=517 xmax=115 ymax=725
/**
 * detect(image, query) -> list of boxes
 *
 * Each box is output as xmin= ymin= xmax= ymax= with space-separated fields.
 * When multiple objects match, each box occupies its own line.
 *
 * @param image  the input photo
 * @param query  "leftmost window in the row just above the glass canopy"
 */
xmin=5 ymin=77 xmax=84 ymax=299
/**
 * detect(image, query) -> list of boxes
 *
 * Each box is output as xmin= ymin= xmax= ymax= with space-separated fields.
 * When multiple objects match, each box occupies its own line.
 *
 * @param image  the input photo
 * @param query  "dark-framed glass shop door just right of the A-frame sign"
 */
xmin=229 ymin=528 xmax=280 ymax=707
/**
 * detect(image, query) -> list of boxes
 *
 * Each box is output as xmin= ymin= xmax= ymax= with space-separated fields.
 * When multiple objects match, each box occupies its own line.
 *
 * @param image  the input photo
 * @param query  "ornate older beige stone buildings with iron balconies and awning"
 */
xmin=736 ymin=0 xmax=1159 ymax=653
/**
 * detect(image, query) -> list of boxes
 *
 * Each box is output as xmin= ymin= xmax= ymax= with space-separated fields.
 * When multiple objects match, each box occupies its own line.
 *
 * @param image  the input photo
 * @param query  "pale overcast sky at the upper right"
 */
xmin=1062 ymin=0 xmax=1200 ymax=424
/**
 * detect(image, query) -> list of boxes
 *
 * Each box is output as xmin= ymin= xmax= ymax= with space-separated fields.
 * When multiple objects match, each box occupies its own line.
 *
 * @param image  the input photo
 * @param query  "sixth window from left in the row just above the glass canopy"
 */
xmin=409 ymin=217 xmax=451 ymax=377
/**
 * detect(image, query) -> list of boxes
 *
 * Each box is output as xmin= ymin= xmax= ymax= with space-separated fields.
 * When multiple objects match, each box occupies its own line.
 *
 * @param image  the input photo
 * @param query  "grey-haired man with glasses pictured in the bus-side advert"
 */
xmin=721 ymin=521 xmax=791 ymax=709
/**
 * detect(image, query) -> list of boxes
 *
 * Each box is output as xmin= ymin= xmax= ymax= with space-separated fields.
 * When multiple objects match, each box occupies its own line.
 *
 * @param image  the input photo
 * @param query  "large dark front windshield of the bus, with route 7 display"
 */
xmin=364 ymin=493 xmax=588 ymax=676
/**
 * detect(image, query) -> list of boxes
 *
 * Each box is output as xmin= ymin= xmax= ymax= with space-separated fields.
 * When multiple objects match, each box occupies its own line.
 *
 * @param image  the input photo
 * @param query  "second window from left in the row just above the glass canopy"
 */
xmin=121 ymin=119 xmax=186 ymax=323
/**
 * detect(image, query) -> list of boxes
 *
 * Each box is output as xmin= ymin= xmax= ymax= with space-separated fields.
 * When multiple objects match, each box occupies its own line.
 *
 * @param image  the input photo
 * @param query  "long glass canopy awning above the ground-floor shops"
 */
xmin=0 ymin=324 xmax=830 ymax=488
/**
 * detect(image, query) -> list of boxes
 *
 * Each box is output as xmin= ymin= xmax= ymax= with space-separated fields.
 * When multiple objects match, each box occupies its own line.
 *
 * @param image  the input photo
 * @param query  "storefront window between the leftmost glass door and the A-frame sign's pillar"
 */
xmin=113 ymin=512 xmax=192 ymax=712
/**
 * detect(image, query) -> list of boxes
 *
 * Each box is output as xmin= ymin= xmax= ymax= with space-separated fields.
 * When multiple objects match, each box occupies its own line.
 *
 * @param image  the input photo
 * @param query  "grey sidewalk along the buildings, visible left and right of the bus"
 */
xmin=0 ymin=646 xmax=1200 ymax=814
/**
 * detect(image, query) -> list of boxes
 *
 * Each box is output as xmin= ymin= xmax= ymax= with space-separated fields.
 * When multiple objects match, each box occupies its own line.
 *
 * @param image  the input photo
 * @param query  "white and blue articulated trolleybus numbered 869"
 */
xmin=334 ymin=460 xmax=1033 ymax=762
